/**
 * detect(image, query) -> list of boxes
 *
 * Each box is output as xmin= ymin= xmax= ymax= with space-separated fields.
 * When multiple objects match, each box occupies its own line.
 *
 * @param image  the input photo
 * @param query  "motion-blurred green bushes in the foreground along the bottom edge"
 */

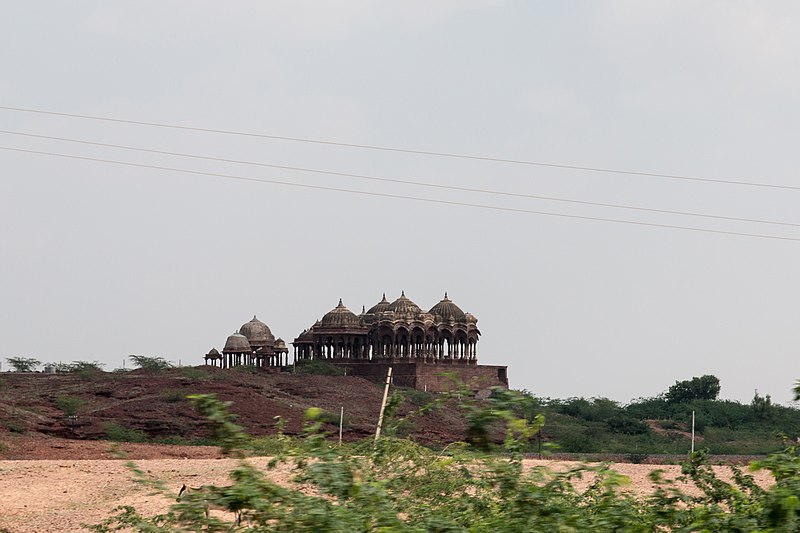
xmin=91 ymin=391 xmax=800 ymax=533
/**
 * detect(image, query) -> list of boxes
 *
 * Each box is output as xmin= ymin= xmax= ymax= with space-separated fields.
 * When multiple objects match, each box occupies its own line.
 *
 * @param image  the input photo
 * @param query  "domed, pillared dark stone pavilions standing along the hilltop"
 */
xmin=205 ymin=292 xmax=481 ymax=367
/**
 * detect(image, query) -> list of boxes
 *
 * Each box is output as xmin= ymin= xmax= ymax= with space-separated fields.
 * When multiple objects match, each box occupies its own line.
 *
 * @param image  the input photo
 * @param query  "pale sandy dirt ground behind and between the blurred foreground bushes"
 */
xmin=0 ymin=436 xmax=768 ymax=533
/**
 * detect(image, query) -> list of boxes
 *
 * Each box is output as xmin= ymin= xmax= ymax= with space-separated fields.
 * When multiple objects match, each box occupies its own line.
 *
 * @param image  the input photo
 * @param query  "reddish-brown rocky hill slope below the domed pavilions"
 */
xmin=0 ymin=366 xmax=465 ymax=443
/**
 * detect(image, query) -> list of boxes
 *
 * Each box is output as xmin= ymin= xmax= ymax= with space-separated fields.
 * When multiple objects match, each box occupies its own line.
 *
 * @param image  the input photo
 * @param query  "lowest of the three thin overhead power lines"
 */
xmin=0 ymin=146 xmax=800 ymax=242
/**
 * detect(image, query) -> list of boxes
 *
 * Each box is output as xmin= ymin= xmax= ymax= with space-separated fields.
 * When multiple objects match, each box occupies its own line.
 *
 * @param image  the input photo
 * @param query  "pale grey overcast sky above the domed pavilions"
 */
xmin=0 ymin=0 xmax=800 ymax=404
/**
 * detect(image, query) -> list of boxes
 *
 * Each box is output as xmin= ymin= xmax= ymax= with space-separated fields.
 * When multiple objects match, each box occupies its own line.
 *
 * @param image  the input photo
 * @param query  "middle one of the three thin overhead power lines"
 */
xmin=0 ymin=130 xmax=800 ymax=227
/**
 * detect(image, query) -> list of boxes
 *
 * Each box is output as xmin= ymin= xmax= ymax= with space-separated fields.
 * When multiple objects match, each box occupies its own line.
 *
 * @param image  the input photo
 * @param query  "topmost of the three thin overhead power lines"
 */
xmin=0 ymin=106 xmax=797 ymax=189
